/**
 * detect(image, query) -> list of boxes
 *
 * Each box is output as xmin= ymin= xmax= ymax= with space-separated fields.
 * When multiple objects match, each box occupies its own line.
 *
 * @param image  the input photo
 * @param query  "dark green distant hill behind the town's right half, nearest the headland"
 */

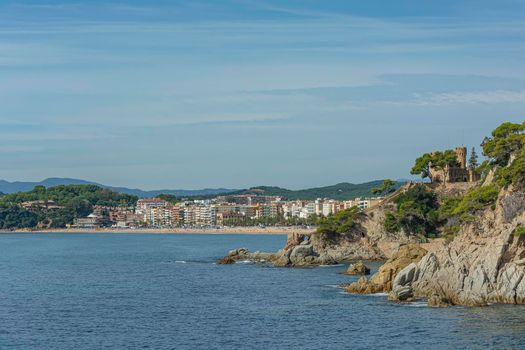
xmin=230 ymin=180 xmax=406 ymax=200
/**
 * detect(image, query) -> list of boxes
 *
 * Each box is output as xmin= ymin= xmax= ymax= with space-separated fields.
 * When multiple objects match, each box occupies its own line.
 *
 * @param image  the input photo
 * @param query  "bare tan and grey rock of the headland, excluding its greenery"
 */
xmin=218 ymin=185 xmax=525 ymax=307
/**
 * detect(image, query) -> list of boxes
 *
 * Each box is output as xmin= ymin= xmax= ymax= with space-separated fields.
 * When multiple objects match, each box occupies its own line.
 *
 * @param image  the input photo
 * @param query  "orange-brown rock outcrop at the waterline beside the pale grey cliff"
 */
xmin=345 ymin=244 xmax=427 ymax=294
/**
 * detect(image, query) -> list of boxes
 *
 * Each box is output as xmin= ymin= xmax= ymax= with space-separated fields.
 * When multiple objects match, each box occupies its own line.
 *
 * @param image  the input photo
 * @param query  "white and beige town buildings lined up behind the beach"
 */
xmin=68 ymin=194 xmax=382 ymax=229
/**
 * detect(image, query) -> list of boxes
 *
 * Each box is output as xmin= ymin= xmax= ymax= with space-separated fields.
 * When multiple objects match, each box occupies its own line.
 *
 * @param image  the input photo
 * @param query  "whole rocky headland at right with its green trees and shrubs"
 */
xmin=219 ymin=122 xmax=525 ymax=307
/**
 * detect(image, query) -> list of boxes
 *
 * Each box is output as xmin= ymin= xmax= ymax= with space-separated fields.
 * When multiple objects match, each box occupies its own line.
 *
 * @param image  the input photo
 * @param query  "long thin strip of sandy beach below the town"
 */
xmin=0 ymin=227 xmax=314 ymax=235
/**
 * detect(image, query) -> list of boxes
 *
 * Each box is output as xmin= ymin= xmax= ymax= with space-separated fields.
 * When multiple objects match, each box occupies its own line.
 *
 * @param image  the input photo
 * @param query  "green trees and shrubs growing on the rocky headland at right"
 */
xmin=384 ymin=119 xmax=525 ymax=237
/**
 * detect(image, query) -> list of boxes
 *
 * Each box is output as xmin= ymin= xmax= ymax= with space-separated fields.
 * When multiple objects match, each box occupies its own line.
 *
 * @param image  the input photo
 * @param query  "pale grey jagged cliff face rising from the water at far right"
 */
xmin=391 ymin=190 xmax=525 ymax=306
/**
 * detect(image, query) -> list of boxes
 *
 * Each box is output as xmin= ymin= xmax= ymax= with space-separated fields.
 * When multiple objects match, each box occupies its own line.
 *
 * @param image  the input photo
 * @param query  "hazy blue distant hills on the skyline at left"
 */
xmin=0 ymin=177 xmax=237 ymax=198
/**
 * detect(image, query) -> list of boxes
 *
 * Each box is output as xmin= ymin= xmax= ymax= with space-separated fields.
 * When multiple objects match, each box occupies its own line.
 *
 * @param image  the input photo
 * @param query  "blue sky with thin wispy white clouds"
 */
xmin=0 ymin=0 xmax=525 ymax=189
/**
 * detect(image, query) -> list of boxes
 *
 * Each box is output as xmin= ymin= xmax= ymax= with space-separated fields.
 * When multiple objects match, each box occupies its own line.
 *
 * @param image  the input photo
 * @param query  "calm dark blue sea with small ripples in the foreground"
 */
xmin=0 ymin=233 xmax=525 ymax=349
